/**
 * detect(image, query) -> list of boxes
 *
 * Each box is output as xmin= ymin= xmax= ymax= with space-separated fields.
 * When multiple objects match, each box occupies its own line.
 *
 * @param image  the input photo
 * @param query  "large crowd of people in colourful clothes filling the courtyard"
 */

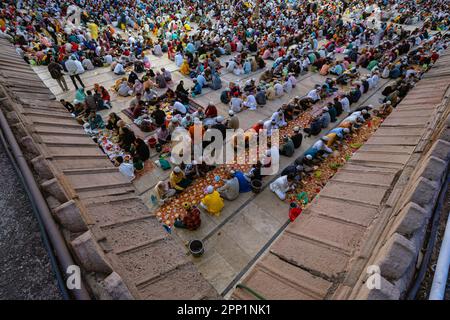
xmin=0 ymin=0 xmax=449 ymax=230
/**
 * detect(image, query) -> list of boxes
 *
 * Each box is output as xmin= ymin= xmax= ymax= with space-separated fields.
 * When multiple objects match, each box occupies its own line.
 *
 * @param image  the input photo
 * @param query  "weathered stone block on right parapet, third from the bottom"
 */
xmin=394 ymin=202 xmax=431 ymax=236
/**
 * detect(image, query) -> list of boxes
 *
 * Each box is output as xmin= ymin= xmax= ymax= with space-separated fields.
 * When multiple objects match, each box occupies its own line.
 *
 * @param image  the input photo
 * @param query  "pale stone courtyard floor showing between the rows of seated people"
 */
xmin=31 ymin=32 xmax=392 ymax=294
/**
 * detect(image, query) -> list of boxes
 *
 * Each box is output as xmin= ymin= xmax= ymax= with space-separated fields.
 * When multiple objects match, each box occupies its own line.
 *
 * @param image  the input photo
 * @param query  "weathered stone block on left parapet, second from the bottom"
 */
xmin=72 ymin=231 xmax=112 ymax=273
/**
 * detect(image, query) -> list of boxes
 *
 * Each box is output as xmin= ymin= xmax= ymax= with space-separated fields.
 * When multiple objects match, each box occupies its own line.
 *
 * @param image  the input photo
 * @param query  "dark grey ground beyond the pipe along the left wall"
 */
xmin=0 ymin=144 xmax=61 ymax=300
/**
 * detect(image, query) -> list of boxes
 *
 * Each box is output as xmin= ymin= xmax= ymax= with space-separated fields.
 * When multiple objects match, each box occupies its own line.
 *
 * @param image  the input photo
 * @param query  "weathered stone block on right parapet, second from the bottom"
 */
xmin=374 ymin=233 xmax=416 ymax=280
